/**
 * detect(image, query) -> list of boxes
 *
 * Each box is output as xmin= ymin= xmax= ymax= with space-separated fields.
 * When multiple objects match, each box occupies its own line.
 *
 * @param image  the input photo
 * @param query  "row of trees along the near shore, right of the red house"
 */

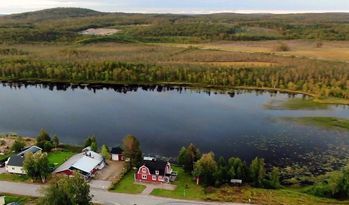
xmin=177 ymin=144 xmax=281 ymax=189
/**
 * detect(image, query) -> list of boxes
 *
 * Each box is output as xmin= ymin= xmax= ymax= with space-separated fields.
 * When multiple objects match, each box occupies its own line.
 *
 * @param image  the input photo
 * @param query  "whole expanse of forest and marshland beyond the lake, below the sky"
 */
xmin=0 ymin=8 xmax=349 ymax=99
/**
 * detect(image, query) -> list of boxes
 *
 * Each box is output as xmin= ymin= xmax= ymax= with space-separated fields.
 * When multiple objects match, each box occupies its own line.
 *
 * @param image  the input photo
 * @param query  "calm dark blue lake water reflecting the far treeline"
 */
xmin=0 ymin=84 xmax=349 ymax=171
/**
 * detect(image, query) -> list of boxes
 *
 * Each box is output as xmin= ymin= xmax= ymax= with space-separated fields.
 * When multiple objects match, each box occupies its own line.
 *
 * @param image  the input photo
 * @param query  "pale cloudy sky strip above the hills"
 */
xmin=0 ymin=0 xmax=349 ymax=14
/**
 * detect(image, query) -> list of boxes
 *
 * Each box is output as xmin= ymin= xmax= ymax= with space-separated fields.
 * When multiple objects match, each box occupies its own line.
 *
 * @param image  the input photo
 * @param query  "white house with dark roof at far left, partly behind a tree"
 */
xmin=5 ymin=146 xmax=42 ymax=174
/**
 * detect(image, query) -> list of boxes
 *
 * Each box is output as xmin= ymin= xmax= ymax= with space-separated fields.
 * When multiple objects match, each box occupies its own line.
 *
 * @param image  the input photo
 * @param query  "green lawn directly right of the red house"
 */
xmin=151 ymin=166 xmax=205 ymax=200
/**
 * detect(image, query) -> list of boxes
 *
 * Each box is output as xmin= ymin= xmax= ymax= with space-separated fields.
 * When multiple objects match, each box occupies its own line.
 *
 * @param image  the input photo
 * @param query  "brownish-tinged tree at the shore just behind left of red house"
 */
xmin=122 ymin=135 xmax=142 ymax=167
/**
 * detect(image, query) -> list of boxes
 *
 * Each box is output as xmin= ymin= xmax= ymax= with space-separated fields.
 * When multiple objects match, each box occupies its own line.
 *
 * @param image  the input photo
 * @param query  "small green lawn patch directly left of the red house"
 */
xmin=112 ymin=171 xmax=145 ymax=194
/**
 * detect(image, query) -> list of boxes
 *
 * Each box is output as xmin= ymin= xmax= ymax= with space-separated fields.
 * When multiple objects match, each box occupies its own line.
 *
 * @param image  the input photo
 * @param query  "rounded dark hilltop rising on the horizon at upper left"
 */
xmin=5 ymin=8 xmax=103 ymax=21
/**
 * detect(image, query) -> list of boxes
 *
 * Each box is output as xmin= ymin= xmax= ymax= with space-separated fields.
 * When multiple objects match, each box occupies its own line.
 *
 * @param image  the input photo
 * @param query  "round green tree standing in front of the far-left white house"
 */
xmin=23 ymin=152 xmax=50 ymax=182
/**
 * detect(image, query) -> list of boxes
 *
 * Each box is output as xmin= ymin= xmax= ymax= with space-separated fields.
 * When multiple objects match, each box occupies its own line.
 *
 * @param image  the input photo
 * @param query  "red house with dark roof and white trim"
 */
xmin=135 ymin=159 xmax=174 ymax=183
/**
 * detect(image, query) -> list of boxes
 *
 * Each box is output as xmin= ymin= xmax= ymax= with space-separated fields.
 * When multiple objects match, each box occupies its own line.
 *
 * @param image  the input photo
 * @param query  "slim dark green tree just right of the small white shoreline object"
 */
xmin=250 ymin=157 xmax=266 ymax=187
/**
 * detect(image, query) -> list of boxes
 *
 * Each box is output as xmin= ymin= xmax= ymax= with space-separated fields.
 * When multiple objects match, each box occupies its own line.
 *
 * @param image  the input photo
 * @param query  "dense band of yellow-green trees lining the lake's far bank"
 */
xmin=0 ymin=59 xmax=349 ymax=99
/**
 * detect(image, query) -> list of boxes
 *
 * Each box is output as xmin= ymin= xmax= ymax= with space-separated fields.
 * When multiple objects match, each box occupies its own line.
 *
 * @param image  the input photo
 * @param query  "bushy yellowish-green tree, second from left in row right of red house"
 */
xmin=193 ymin=152 xmax=218 ymax=186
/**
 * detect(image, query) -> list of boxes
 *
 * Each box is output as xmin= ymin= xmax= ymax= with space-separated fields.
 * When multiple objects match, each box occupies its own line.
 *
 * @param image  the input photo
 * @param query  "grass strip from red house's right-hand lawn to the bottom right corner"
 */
xmin=151 ymin=167 xmax=349 ymax=205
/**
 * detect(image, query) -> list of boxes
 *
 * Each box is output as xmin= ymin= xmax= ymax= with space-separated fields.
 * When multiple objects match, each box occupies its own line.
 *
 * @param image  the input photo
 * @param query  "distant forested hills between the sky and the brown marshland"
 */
xmin=0 ymin=8 xmax=349 ymax=43
